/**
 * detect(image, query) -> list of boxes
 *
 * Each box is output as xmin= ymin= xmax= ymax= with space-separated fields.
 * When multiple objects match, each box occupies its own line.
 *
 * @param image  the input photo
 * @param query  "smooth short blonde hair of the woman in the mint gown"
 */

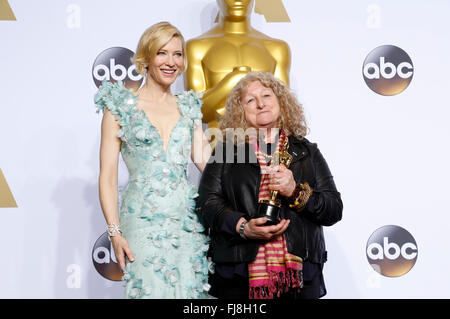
xmin=131 ymin=21 xmax=187 ymax=76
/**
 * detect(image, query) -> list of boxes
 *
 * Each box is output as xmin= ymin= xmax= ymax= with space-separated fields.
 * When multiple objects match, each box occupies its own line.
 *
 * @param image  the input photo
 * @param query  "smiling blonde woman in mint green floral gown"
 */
xmin=95 ymin=22 xmax=211 ymax=298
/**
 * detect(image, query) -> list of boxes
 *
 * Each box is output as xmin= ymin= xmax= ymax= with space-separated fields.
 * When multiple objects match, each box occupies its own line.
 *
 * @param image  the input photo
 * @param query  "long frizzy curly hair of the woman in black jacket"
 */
xmin=219 ymin=72 xmax=308 ymax=142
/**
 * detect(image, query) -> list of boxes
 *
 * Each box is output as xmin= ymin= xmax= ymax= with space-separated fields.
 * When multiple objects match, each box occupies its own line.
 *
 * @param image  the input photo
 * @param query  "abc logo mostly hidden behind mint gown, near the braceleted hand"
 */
xmin=92 ymin=232 xmax=123 ymax=281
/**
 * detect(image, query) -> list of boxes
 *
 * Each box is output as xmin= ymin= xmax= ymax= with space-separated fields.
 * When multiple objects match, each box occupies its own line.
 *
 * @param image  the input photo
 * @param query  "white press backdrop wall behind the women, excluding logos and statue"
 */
xmin=0 ymin=0 xmax=450 ymax=298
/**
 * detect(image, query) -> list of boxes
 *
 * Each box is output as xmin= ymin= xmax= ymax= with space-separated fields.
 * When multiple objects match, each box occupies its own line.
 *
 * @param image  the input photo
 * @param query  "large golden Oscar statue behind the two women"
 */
xmin=185 ymin=0 xmax=291 ymax=127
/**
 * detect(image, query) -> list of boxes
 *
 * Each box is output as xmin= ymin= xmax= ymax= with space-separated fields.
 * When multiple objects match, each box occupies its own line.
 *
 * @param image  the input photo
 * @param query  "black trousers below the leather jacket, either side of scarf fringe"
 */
xmin=209 ymin=271 xmax=325 ymax=299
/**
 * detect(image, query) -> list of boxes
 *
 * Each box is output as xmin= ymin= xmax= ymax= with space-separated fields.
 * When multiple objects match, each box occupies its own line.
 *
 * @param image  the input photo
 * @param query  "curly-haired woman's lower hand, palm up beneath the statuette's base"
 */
xmin=244 ymin=217 xmax=290 ymax=240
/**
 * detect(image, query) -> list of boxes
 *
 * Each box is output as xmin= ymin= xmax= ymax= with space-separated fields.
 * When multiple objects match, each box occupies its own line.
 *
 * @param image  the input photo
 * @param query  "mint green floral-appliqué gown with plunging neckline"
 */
xmin=95 ymin=81 xmax=211 ymax=299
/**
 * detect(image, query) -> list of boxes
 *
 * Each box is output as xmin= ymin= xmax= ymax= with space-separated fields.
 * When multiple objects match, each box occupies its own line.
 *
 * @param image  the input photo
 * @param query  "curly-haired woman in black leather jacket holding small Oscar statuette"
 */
xmin=197 ymin=72 xmax=343 ymax=299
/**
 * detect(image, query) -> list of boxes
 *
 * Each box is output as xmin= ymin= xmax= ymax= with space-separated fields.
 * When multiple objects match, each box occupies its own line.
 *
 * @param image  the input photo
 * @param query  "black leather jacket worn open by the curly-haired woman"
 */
xmin=196 ymin=136 xmax=343 ymax=264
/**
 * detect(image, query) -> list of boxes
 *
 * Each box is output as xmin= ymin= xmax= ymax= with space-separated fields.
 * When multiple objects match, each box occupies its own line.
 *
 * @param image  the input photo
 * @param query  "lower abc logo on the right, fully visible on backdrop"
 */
xmin=366 ymin=225 xmax=418 ymax=277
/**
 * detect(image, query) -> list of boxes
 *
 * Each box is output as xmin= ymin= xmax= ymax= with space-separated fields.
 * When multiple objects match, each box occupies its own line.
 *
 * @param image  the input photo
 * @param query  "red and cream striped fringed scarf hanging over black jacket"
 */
xmin=248 ymin=131 xmax=303 ymax=299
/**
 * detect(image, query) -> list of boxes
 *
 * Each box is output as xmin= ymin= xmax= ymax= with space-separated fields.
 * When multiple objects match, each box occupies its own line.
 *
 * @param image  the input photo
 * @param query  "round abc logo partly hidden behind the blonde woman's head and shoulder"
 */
xmin=92 ymin=47 xmax=143 ymax=90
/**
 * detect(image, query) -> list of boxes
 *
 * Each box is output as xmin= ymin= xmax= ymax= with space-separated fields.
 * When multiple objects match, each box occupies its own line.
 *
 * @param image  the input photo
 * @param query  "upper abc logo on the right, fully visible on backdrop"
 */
xmin=363 ymin=45 xmax=414 ymax=95
